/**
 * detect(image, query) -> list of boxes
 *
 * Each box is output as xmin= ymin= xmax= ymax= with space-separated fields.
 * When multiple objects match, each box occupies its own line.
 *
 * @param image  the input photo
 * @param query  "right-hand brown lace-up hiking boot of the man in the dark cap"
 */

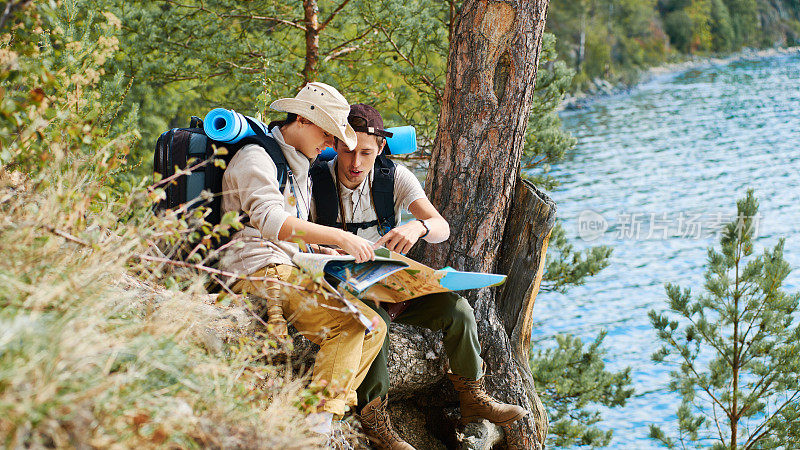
xmin=447 ymin=373 xmax=528 ymax=426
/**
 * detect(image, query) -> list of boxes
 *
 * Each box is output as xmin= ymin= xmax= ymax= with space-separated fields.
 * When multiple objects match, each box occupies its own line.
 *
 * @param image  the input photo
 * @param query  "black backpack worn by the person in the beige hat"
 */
xmin=153 ymin=117 xmax=289 ymax=234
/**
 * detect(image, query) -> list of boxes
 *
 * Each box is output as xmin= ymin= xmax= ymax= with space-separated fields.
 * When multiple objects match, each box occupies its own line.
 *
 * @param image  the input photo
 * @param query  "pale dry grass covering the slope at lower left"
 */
xmin=0 ymin=167 xmax=332 ymax=448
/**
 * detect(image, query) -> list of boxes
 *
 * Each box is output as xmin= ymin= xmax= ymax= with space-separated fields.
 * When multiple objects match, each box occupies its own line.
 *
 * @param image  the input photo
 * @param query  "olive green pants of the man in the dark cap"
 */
xmin=356 ymin=292 xmax=483 ymax=411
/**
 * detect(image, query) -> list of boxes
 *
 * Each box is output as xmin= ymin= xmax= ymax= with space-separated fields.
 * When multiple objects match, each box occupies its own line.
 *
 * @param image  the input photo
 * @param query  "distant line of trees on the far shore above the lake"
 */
xmin=547 ymin=0 xmax=800 ymax=89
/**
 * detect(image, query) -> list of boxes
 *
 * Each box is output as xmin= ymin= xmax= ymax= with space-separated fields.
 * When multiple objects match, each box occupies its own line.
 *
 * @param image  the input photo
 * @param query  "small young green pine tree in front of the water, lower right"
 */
xmin=650 ymin=189 xmax=800 ymax=449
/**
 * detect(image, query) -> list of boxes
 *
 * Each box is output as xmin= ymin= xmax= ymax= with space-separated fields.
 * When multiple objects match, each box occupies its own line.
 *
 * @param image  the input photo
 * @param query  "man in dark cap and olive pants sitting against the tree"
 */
xmin=310 ymin=104 xmax=527 ymax=449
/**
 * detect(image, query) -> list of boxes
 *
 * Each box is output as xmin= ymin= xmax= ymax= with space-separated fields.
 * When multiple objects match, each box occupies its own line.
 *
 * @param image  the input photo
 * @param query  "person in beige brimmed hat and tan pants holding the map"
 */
xmin=221 ymin=82 xmax=386 ymax=432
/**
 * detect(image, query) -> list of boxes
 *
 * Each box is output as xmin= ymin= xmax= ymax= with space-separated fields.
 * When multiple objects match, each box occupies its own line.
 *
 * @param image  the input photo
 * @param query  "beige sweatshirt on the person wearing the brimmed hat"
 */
xmin=220 ymin=127 xmax=311 ymax=275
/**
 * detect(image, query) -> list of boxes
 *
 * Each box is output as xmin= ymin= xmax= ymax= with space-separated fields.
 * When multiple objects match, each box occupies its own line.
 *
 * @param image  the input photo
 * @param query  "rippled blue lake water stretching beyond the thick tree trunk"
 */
xmin=533 ymin=52 xmax=800 ymax=449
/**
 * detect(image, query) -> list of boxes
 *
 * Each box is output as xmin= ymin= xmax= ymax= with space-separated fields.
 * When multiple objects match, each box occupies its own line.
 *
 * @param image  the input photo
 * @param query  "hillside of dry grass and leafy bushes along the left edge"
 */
xmin=0 ymin=4 xmax=368 ymax=449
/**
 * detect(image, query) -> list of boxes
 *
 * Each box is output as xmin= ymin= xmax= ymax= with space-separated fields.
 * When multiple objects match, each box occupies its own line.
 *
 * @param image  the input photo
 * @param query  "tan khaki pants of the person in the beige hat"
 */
xmin=233 ymin=264 xmax=387 ymax=416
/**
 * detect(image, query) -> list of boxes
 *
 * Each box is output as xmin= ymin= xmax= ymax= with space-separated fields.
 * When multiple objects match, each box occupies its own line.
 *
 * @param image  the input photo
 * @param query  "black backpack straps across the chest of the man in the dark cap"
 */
xmin=309 ymin=155 xmax=397 ymax=236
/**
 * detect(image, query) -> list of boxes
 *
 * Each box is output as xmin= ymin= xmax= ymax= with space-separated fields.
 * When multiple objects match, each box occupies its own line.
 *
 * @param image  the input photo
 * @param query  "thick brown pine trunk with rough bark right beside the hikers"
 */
xmin=414 ymin=0 xmax=555 ymax=448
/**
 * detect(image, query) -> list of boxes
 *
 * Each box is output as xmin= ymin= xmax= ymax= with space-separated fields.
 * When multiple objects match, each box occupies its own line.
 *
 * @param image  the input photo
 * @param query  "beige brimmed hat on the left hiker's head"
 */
xmin=269 ymin=81 xmax=357 ymax=150
